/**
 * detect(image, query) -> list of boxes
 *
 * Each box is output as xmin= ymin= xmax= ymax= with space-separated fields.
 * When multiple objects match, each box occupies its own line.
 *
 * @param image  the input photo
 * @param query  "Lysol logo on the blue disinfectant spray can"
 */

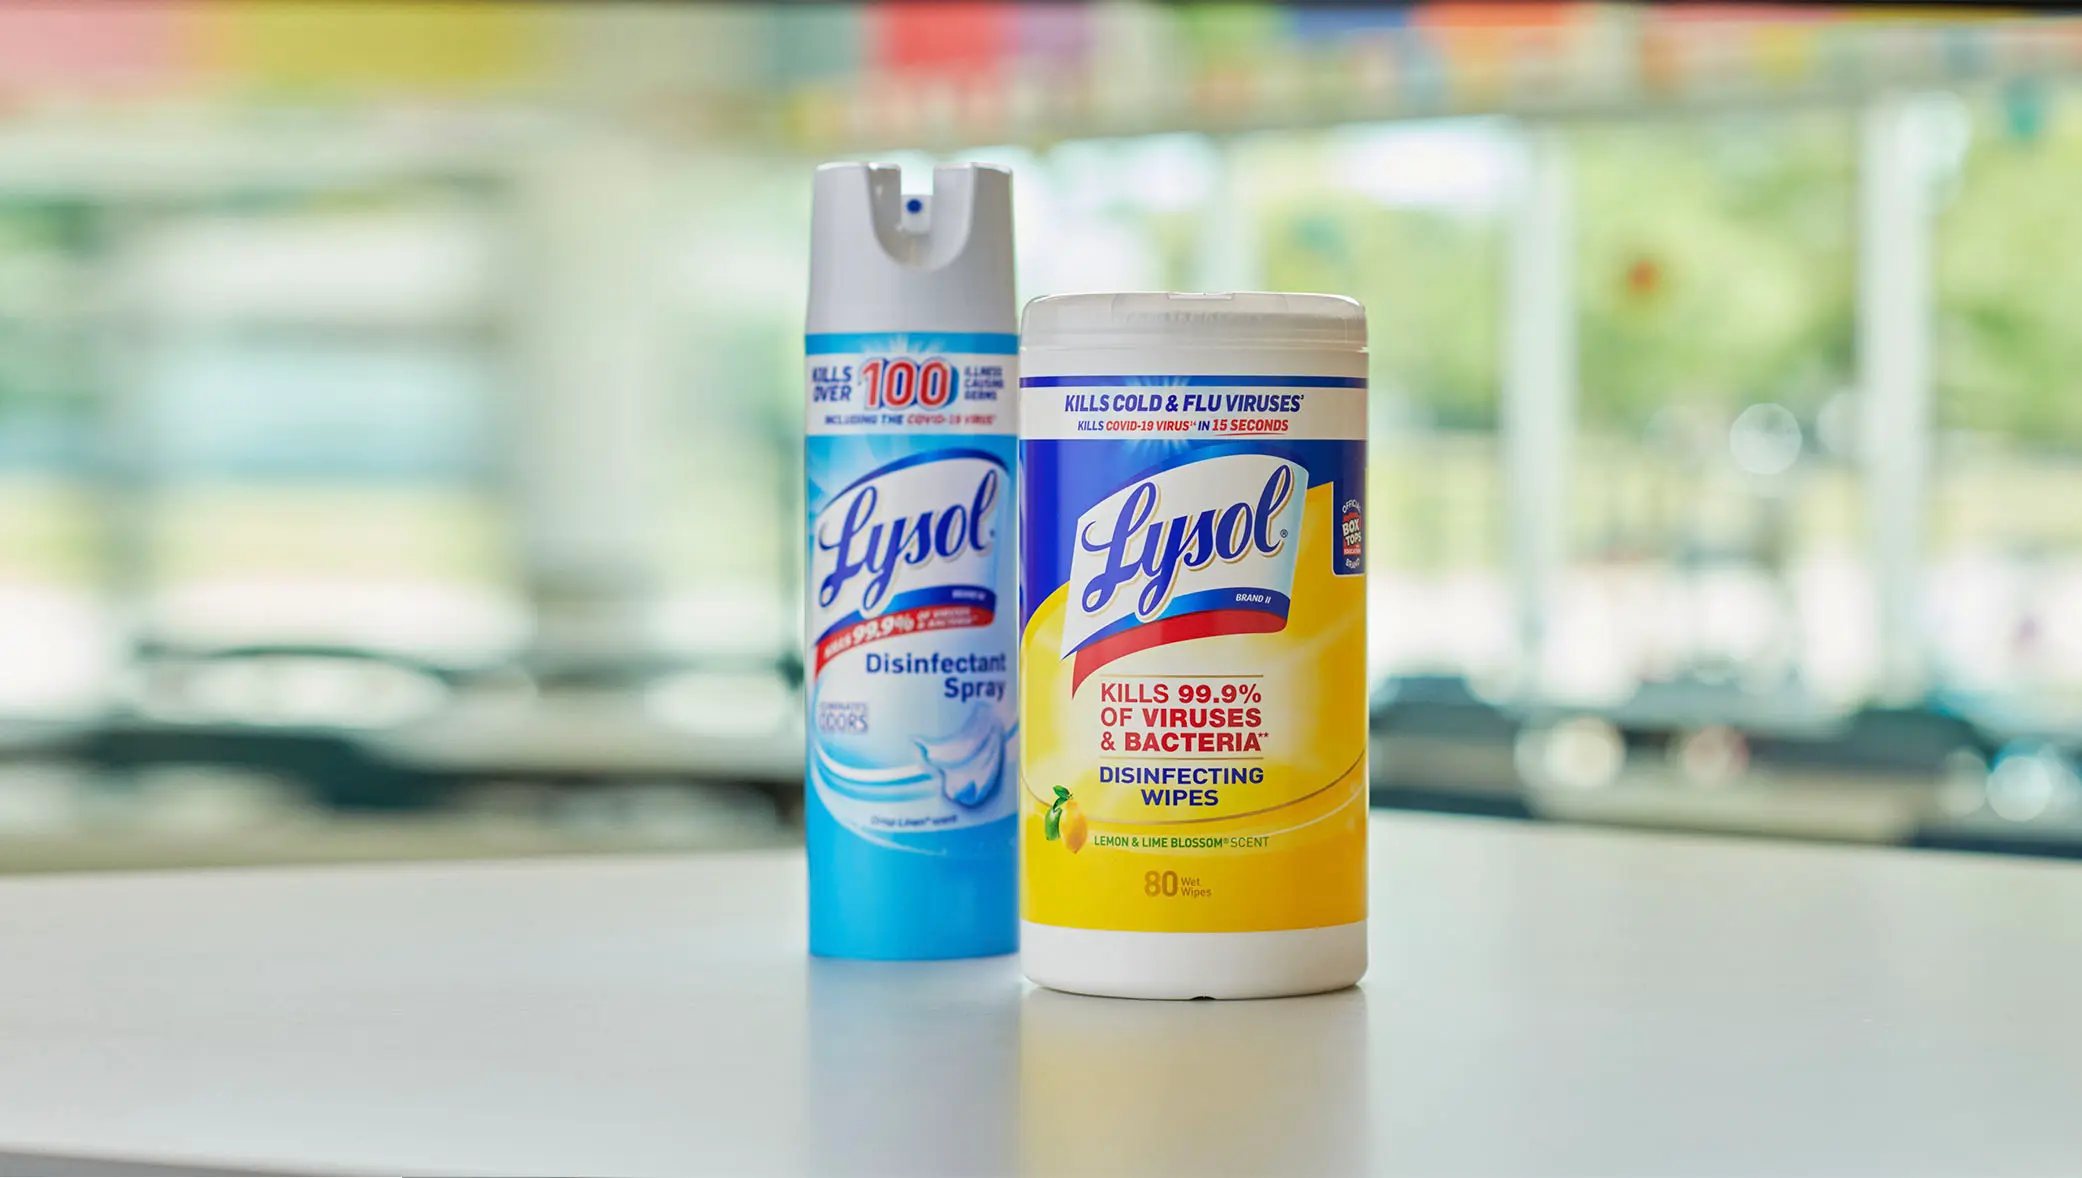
xmin=810 ymin=450 xmax=1006 ymax=668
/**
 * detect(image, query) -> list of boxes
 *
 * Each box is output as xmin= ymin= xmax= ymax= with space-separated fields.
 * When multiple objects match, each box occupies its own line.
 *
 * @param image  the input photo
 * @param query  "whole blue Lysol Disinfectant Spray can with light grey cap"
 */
xmin=804 ymin=164 xmax=1018 ymax=959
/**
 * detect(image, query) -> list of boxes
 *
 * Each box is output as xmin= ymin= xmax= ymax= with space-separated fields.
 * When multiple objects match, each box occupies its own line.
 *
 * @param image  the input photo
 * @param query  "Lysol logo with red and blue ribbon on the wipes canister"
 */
xmin=1062 ymin=454 xmax=1307 ymax=691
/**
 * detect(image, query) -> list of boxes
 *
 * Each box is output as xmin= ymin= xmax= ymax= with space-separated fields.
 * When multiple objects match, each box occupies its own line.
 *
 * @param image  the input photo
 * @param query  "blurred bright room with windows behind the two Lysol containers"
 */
xmin=0 ymin=0 xmax=2082 ymax=870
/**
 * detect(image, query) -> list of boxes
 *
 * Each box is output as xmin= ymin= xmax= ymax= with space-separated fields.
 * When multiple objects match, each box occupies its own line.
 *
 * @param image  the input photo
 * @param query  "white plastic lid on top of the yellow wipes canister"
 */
xmin=1020 ymin=291 xmax=1366 ymax=352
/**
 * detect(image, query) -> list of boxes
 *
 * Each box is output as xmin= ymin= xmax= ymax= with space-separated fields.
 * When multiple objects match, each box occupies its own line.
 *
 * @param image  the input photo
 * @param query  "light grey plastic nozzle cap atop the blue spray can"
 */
xmin=808 ymin=164 xmax=1018 ymax=333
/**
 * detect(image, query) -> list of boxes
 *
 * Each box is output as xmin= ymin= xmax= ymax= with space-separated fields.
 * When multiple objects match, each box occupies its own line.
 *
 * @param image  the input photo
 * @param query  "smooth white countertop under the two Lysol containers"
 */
xmin=0 ymin=816 xmax=2082 ymax=1176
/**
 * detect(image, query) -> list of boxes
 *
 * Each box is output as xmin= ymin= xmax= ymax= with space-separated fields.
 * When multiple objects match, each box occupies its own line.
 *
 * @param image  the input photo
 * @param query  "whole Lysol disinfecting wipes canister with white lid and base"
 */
xmin=1020 ymin=293 xmax=1366 ymax=999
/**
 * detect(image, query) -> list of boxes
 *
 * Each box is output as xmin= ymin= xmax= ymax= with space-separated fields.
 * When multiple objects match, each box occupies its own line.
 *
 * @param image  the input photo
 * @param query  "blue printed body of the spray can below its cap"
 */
xmin=804 ymin=335 xmax=1018 ymax=957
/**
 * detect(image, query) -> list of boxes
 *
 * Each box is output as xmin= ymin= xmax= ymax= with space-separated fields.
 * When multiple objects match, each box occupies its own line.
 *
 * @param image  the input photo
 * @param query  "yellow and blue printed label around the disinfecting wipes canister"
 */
xmin=1020 ymin=377 xmax=1366 ymax=932
